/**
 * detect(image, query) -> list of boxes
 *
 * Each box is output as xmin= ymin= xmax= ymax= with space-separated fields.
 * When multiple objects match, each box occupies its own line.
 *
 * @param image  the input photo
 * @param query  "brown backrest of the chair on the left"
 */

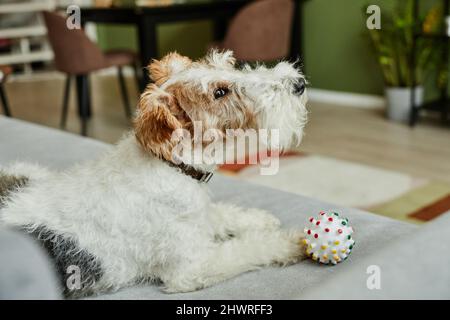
xmin=43 ymin=11 xmax=107 ymax=74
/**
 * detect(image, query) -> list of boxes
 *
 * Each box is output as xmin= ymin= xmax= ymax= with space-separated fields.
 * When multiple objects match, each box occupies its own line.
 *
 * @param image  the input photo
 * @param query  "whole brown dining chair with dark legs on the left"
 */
xmin=43 ymin=11 xmax=139 ymax=136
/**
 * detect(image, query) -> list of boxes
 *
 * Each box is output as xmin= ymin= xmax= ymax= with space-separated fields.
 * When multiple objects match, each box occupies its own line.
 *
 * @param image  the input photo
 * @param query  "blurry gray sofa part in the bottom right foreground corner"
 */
xmin=297 ymin=212 xmax=450 ymax=299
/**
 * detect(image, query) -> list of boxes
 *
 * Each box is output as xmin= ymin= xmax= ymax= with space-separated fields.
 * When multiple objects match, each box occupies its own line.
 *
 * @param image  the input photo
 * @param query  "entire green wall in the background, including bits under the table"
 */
xmin=98 ymin=0 xmax=440 ymax=94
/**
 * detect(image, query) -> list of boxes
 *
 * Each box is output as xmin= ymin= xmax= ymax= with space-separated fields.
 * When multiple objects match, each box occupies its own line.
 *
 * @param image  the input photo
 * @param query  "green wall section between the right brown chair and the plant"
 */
xmin=304 ymin=0 xmax=394 ymax=94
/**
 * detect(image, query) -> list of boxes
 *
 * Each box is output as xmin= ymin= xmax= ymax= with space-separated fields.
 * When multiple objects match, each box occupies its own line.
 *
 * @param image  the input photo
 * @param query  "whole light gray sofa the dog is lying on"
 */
xmin=0 ymin=117 xmax=450 ymax=299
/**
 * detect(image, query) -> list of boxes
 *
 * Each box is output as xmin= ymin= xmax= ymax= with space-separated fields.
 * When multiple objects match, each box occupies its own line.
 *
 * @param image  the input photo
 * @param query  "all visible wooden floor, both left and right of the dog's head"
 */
xmin=2 ymin=75 xmax=450 ymax=181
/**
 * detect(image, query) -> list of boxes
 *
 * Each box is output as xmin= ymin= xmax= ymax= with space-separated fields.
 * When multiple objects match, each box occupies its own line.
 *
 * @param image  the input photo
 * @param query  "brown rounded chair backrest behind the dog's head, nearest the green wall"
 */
xmin=223 ymin=0 xmax=294 ymax=61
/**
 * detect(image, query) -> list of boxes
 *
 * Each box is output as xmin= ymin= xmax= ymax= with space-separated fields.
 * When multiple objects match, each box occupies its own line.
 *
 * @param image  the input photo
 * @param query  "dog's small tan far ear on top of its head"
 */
xmin=148 ymin=52 xmax=192 ymax=86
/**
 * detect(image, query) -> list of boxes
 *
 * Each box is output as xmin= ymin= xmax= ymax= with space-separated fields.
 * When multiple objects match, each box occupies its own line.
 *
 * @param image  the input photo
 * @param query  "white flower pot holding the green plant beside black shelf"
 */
xmin=385 ymin=86 xmax=423 ymax=123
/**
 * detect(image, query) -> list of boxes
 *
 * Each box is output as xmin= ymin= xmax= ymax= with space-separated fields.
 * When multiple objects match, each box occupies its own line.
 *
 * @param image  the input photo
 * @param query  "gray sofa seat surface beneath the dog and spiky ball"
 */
xmin=0 ymin=117 xmax=424 ymax=299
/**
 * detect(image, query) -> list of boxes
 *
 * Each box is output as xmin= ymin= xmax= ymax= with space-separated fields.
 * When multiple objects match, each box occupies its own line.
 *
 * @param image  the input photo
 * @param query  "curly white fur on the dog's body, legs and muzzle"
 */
xmin=0 ymin=53 xmax=306 ymax=298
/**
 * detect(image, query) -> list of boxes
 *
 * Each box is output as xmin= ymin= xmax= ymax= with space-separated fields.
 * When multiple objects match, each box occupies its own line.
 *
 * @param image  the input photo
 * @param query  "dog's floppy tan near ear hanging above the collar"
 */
xmin=134 ymin=84 xmax=183 ymax=161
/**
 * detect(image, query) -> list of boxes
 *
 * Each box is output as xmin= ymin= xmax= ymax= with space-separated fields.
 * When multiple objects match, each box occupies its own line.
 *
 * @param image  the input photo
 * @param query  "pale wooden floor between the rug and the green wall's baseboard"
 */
xmin=301 ymin=104 xmax=450 ymax=181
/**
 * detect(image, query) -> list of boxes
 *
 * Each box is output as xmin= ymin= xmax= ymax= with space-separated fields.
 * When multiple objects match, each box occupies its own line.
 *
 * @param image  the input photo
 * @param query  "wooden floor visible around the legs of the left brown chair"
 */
xmin=6 ymin=70 xmax=139 ymax=143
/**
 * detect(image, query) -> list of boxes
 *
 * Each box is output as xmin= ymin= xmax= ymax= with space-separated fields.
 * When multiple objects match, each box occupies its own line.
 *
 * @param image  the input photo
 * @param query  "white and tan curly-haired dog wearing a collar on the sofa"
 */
xmin=0 ymin=51 xmax=307 ymax=297
